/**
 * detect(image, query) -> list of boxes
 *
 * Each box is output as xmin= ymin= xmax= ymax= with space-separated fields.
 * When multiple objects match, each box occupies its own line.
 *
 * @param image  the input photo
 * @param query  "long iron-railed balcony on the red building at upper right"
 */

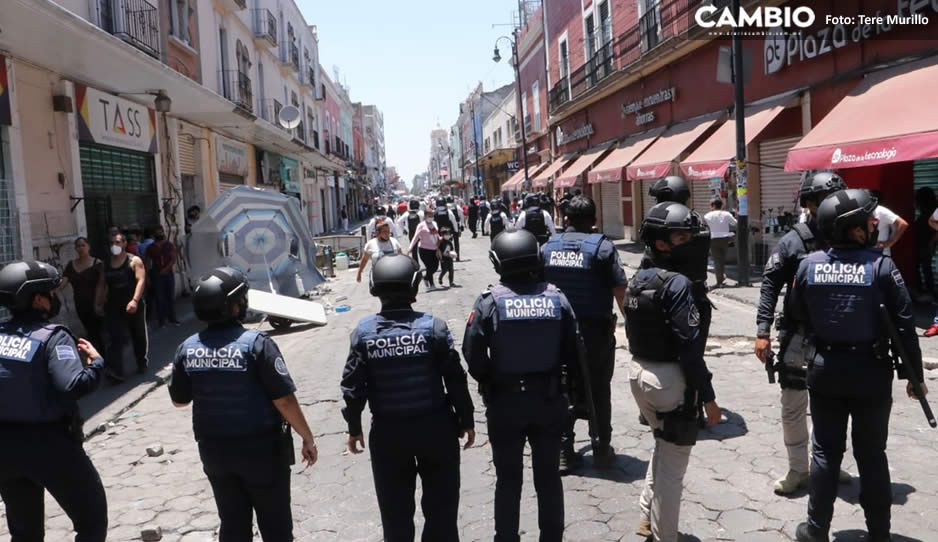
xmin=548 ymin=0 xmax=704 ymax=114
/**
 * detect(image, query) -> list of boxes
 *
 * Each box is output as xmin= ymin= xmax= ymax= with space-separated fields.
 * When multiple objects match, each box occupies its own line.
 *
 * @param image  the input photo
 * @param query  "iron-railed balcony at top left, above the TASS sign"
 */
xmin=95 ymin=0 xmax=160 ymax=58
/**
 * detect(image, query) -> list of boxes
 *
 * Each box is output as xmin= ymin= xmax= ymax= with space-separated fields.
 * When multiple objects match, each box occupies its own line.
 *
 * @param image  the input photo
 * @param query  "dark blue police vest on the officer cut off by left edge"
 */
xmin=0 ymin=319 xmax=77 ymax=423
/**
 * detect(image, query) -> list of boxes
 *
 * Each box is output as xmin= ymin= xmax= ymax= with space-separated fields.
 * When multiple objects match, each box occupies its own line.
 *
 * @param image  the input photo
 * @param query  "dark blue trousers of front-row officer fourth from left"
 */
xmin=485 ymin=391 xmax=568 ymax=542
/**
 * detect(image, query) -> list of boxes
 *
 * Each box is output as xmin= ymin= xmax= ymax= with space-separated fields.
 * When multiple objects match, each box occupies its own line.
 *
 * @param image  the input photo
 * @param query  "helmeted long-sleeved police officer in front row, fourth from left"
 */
xmin=463 ymin=230 xmax=582 ymax=542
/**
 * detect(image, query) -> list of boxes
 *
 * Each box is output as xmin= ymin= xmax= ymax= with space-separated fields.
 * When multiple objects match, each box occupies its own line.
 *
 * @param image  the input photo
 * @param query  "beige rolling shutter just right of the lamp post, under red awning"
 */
xmin=759 ymin=136 xmax=801 ymax=220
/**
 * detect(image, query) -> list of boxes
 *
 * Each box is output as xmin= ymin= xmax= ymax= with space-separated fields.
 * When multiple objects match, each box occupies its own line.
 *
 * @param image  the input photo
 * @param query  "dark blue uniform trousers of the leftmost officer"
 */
xmin=0 ymin=428 xmax=107 ymax=542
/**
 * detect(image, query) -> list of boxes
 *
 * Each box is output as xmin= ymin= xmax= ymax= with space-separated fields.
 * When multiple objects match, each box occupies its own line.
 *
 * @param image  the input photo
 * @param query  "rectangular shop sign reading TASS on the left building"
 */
xmin=75 ymin=85 xmax=156 ymax=154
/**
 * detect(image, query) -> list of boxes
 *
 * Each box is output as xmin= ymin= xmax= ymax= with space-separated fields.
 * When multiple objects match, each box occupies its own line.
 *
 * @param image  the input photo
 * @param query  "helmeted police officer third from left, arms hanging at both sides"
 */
xmin=342 ymin=256 xmax=475 ymax=542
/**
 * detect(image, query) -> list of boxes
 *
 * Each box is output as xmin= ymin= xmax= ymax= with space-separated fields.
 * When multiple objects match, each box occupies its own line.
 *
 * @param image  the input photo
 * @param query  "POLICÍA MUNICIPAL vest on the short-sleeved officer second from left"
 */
xmin=182 ymin=327 xmax=282 ymax=440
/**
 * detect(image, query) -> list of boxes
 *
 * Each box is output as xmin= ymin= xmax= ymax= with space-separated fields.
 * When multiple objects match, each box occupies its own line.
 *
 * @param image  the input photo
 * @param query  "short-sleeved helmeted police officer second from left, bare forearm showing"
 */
xmin=169 ymin=267 xmax=317 ymax=542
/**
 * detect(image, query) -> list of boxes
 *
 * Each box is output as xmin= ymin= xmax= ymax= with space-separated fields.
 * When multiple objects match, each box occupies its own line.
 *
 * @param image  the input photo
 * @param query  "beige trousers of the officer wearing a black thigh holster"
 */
xmin=629 ymin=358 xmax=693 ymax=542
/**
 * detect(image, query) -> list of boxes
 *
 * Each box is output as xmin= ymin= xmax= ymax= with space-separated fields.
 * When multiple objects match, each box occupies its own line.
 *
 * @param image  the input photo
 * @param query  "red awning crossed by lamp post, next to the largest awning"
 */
xmin=681 ymin=104 xmax=785 ymax=180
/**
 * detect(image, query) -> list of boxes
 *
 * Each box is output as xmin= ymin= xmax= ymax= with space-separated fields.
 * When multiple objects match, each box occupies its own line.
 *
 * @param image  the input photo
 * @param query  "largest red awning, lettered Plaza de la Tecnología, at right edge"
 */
xmin=785 ymin=59 xmax=938 ymax=171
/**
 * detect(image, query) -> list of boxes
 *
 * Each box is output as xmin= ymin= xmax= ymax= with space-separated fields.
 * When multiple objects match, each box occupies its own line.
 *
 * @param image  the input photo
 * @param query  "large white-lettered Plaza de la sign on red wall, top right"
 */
xmin=762 ymin=0 xmax=938 ymax=75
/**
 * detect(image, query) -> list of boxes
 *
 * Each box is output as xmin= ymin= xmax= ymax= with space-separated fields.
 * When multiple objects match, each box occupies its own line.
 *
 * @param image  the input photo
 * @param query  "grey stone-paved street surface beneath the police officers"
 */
xmin=0 ymin=235 xmax=938 ymax=542
